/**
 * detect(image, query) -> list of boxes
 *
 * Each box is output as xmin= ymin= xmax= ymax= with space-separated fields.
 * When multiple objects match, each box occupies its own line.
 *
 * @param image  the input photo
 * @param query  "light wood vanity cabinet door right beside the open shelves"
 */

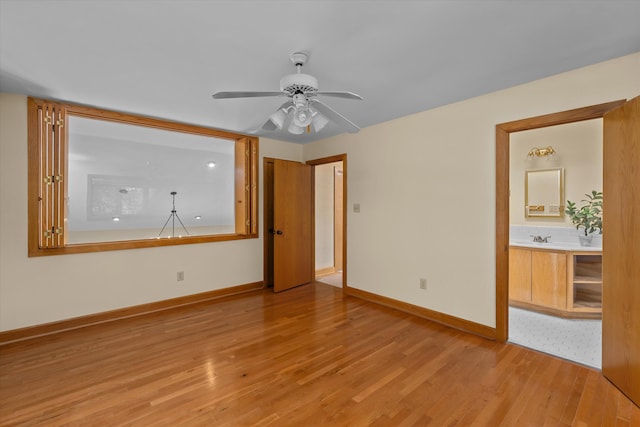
xmin=531 ymin=251 xmax=567 ymax=310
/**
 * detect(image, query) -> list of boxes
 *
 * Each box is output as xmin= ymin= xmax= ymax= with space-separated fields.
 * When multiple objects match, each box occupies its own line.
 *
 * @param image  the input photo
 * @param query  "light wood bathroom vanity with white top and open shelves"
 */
xmin=509 ymin=242 xmax=602 ymax=318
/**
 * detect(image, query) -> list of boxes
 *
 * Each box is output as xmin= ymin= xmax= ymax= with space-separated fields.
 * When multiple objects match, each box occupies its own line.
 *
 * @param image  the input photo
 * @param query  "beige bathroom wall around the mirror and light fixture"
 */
xmin=509 ymin=119 xmax=602 ymax=227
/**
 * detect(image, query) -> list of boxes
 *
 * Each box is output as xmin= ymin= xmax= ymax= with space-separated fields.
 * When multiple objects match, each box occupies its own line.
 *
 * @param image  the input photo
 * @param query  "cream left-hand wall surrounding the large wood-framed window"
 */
xmin=0 ymin=94 xmax=302 ymax=331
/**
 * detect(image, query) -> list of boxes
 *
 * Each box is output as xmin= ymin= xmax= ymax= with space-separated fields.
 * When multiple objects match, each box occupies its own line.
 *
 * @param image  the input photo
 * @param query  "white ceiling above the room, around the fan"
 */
xmin=0 ymin=0 xmax=640 ymax=143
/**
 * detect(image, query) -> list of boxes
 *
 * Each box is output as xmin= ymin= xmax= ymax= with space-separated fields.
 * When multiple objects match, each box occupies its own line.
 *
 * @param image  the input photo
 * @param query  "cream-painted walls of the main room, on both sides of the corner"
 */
xmin=0 ymin=54 xmax=640 ymax=330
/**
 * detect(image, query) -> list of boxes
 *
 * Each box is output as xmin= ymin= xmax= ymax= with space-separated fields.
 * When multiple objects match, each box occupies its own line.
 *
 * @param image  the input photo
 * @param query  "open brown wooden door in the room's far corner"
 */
xmin=273 ymin=160 xmax=314 ymax=292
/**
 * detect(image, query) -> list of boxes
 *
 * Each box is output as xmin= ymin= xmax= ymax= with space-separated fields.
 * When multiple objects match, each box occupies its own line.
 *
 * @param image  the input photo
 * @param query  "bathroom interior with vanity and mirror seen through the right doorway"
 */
xmin=509 ymin=118 xmax=603 ymax=369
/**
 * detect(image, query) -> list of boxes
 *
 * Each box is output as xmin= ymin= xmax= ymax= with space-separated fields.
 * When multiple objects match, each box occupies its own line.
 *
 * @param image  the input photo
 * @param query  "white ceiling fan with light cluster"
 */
xmin=213 ymin=52 xmax=362 ymax=134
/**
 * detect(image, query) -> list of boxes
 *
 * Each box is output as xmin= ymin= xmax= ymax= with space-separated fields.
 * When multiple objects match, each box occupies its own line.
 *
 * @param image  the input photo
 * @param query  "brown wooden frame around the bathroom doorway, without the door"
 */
xmin=496 ymin=99 xmax=626 ymax=342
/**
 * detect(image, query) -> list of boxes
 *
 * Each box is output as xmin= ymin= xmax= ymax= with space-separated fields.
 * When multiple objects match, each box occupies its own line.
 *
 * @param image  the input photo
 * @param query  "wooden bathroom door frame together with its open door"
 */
xmin=496 ymin=96 xmax=640 ymax=405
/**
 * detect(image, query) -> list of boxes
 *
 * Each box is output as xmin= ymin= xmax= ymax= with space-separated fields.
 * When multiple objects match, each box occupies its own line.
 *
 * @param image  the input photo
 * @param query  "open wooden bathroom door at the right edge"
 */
xmin=602 ymin=97 xmax=640 ymax=405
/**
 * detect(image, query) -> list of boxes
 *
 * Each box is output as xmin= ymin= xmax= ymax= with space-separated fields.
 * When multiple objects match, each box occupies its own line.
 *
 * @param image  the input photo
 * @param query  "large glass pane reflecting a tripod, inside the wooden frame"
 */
xmin=66 ymin=116 xmax=235 ymax=243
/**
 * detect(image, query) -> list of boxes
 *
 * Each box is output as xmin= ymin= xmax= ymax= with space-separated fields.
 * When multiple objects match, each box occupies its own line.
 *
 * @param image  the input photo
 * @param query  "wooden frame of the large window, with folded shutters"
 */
xmin=27 ymin=98 xmax=259 ymax=257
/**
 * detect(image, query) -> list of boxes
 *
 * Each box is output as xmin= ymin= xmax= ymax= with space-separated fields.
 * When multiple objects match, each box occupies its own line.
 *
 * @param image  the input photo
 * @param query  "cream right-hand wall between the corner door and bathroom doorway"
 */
xmin=304 ymin=53 xmax=640 ymax=327
